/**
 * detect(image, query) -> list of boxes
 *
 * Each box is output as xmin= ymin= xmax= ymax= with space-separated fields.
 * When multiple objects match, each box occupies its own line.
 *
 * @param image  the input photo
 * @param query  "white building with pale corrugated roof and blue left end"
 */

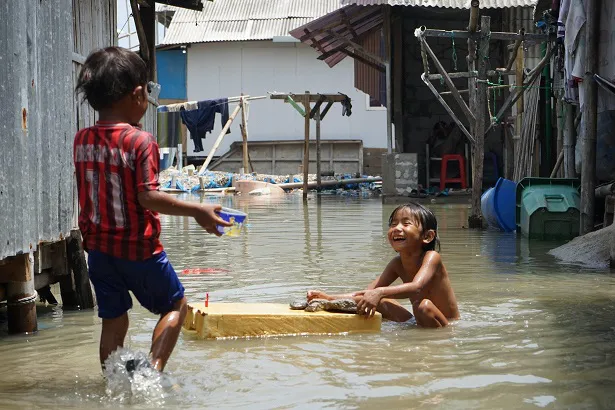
xmin=157 ymin=0 xmax=386 ymax=175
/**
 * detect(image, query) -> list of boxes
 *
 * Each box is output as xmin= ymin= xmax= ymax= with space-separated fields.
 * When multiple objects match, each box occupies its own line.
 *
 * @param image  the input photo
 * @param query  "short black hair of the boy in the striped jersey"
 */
xmin=75 ymin=47 xmax=148 ymax=111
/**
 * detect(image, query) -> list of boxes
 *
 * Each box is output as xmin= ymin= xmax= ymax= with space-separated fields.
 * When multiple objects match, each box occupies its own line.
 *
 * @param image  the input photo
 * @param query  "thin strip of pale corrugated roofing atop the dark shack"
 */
xmin=340 ymin=0 xmax=538 ymax=9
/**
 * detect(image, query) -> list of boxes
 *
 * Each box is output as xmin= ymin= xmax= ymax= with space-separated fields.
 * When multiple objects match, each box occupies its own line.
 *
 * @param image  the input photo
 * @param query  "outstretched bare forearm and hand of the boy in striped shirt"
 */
xmin=137 ymin=191 xmax=232 ymax=236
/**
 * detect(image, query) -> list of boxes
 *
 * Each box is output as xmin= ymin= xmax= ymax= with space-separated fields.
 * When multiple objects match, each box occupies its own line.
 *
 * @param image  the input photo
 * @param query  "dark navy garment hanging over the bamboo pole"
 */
xmin=180 ymin=98 xmax=231 ymax=152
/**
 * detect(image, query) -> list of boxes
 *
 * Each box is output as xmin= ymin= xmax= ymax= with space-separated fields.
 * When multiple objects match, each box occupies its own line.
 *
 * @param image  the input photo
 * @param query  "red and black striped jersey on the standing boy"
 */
xmin=74 ymin=121 xmax=163 ymax=260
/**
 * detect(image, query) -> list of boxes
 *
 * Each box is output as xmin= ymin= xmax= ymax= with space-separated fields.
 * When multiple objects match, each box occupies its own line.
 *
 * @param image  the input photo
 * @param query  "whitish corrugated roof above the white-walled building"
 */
xmin=162 ymin=0 xmax=339 ymax=45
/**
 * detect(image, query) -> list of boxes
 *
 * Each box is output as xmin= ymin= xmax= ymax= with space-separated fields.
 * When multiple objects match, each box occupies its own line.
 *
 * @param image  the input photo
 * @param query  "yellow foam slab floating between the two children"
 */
xmin=184 ymin=303 xmax=382 ymax=339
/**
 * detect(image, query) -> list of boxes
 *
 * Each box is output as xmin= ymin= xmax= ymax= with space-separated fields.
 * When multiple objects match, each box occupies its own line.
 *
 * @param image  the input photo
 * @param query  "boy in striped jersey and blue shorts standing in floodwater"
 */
xmin=74 ymin=47 xmax=230 ymax=371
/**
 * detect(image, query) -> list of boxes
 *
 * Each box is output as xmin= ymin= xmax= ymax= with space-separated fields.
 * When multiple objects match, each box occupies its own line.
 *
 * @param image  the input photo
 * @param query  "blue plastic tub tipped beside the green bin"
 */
xmin=480 ymin=178 xmax=517 ymax=232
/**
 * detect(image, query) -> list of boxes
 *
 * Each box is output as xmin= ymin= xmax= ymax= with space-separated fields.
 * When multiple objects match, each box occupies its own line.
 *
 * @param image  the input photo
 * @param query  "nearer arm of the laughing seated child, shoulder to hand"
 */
xmin=356 ymin=251 xmax=442 ymax=316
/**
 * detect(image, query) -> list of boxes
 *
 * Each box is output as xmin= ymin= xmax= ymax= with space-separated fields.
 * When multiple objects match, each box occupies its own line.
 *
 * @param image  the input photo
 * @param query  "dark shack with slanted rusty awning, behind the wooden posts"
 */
xmin=291 ymin=0 xmax=551 ymax=196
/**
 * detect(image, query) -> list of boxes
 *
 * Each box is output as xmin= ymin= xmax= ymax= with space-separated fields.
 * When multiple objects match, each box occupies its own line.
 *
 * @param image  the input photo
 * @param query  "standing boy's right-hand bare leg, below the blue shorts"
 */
xmin=150 ymin=297 xmax=188 ymax=371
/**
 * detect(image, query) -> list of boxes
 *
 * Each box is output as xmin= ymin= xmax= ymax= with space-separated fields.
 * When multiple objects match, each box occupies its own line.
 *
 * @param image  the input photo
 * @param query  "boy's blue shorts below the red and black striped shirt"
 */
xmin=88 ymin=251 xmax=184 ymax=319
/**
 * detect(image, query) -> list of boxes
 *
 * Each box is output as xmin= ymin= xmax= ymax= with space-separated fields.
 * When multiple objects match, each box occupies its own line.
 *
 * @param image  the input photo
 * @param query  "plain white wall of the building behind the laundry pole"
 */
xmin=187 ymin=41 xmax=387 ymax=156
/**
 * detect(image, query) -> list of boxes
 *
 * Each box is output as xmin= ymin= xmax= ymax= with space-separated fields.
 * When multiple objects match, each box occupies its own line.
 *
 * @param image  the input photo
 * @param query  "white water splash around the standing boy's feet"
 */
xmin=103 ymin=348 xmax=177 ymax=406
